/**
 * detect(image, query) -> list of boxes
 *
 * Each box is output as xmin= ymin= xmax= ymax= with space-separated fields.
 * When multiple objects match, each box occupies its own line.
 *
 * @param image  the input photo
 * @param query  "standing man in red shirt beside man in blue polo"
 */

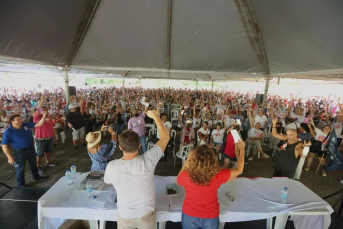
xmin=33 ymin=104 xmax=57 ymax=174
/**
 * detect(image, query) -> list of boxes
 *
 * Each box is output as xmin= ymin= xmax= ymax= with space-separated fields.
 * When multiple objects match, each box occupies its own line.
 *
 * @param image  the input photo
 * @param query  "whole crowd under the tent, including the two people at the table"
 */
xmin=0 ymin=87 xmax=343 ymax=228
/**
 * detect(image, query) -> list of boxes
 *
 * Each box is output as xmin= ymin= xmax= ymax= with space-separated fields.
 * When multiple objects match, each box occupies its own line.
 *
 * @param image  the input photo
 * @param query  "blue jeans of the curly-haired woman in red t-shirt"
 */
xmin=181 ymin=212 xmax=219 ymax=229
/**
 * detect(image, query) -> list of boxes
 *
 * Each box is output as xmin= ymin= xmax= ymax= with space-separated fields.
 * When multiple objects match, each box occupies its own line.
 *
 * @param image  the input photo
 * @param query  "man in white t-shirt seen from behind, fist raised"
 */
xmin=104 ymin=110 xmax=169 ymax=229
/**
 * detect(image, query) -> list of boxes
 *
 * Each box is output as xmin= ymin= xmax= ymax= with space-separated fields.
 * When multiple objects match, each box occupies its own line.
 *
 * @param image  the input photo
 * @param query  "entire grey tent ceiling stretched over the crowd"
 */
xmin=0 ymin=0 xmax=343 ymax=80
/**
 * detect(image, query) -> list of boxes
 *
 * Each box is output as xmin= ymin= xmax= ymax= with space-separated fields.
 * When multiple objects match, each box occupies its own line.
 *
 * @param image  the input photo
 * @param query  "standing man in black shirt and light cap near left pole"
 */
xmin=66 ymin=103 xmax=87 ymax=150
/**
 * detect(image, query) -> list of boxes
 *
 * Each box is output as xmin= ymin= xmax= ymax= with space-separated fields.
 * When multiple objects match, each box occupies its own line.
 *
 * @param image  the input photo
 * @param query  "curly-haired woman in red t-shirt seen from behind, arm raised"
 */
xmin=177 ymin=141 xmax=245 ymax=229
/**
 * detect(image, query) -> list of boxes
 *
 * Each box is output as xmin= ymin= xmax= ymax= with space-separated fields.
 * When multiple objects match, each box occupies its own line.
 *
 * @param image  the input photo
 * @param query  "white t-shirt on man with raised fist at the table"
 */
xmin=104 ymin=145 xmax=162 ymax=219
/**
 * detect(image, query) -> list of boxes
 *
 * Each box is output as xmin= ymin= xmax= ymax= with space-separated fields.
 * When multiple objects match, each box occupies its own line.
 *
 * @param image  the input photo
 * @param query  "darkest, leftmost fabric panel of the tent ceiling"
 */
xmin=0 ymin=0 xmax=92 ymax=65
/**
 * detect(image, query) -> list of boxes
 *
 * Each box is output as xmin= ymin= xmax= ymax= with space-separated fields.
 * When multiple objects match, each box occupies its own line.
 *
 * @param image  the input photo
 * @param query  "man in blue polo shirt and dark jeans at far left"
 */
xmin=2 ymin=114 xmax=46 ymax=187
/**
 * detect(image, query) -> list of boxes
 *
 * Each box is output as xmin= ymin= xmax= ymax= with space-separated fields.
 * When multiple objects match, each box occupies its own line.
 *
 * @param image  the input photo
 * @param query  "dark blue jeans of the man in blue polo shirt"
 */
xmin=13 ymin=145 xmax=38 ymax=187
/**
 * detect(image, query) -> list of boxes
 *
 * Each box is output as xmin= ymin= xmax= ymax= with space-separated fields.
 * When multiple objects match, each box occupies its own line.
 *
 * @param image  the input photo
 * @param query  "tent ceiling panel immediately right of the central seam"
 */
xmin=171 ymin=0 xmax=264 ymax=73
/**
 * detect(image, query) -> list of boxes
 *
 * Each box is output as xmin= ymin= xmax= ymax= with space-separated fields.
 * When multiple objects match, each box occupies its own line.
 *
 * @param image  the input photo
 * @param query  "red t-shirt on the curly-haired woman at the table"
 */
xmin=177 ymin=169 xmax=231 ymax=219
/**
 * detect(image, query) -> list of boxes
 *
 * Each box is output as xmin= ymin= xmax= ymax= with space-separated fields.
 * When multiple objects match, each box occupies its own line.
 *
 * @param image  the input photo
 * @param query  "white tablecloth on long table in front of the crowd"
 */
xmin=38 ymin=174 xmax=333 ymax=229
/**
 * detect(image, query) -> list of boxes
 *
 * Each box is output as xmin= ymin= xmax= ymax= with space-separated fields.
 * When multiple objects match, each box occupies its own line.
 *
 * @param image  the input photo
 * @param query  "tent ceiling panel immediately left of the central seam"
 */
xmin=73 ymin=0 xmax=168 ymax=69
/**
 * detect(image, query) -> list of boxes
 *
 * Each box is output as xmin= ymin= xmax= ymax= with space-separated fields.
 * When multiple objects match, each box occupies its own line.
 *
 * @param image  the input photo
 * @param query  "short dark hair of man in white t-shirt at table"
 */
xmin=118 ymin=130 xmax=141 ymax=153
